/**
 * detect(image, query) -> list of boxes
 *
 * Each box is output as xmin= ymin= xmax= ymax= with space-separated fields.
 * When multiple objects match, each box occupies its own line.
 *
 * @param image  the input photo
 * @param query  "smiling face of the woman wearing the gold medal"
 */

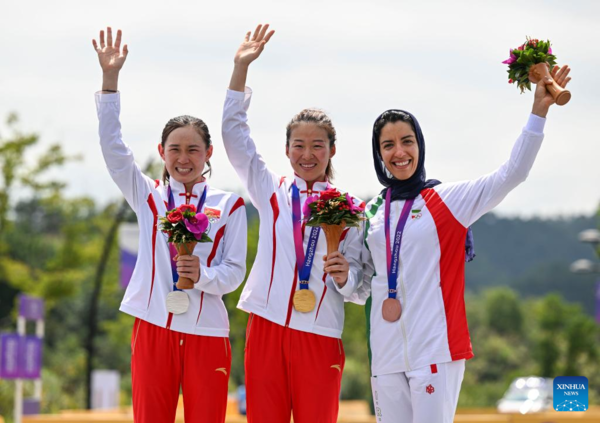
xmin=285 ymin=122 xmax=335 ymax=182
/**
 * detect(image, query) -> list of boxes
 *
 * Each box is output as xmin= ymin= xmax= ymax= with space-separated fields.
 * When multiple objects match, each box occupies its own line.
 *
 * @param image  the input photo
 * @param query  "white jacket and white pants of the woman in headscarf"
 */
xmin=355 ymin=115 xmax=545 ymax=423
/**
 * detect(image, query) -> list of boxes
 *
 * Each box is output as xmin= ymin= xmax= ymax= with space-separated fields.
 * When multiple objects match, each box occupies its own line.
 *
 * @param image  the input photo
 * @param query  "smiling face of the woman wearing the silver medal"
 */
xmin=158 ymin=125 xmax=213 ymax=191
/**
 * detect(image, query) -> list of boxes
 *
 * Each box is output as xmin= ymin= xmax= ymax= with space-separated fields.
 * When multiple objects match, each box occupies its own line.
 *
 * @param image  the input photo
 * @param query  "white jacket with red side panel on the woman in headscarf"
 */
xmin=355 ymin=115 xmax=545 ymax=376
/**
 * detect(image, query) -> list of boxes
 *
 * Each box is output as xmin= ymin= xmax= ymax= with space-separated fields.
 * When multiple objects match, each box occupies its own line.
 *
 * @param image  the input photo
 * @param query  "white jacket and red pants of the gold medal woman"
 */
xmin=222 ymin=88 xmax=362 ymax=423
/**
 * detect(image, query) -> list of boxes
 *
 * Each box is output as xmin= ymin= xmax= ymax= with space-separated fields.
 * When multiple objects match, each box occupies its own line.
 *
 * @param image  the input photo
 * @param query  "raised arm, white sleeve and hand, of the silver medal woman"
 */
xmin=92 ymin=28 xmax=154 ymax=211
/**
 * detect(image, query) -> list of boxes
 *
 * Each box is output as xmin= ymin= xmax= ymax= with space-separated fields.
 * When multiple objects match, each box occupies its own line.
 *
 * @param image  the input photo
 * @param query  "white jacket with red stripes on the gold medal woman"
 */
xmin=222 ymin=88 xmax=362 ymax=338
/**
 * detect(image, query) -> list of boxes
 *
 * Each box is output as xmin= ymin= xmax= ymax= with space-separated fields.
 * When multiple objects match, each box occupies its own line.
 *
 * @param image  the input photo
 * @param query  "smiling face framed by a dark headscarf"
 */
xmin=379 ymin=121 xmax=419 ymax=181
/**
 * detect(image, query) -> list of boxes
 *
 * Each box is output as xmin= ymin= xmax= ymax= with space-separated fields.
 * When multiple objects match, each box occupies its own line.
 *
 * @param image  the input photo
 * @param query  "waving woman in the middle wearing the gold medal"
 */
xmin=222 ymin=25 xmax=362 ymax=423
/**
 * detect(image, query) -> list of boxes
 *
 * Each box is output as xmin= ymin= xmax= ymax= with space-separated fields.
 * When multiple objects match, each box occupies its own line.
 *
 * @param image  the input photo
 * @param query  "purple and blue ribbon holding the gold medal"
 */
xmin=292 ymin=183 xmax=321 ymax=289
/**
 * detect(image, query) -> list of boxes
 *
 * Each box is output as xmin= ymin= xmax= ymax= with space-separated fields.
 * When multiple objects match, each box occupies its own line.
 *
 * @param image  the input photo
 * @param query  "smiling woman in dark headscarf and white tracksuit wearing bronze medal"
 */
xmin=357 ymin=66 xmax=570 ymax=423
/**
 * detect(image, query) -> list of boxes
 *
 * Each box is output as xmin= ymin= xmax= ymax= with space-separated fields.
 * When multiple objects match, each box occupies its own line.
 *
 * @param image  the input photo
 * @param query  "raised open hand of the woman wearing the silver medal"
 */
xmin=92 ymin=27 xmax=129 ymax=91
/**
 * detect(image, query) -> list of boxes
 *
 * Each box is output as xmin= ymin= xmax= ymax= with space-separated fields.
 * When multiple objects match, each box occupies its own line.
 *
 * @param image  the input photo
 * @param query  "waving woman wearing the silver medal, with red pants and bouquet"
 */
xmin=93 ymin=28 xmax=247 ymax=423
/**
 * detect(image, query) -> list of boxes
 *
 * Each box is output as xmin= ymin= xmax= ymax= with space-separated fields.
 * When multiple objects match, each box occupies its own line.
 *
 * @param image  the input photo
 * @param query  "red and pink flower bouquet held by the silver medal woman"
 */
xmin=160 ymin=204 xmax=212 ymax=289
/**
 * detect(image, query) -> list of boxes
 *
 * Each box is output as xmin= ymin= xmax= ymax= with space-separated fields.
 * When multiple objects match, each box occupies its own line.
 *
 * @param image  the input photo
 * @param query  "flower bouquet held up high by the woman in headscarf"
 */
xmin=502 ymin=37 xmax=571 ymax=106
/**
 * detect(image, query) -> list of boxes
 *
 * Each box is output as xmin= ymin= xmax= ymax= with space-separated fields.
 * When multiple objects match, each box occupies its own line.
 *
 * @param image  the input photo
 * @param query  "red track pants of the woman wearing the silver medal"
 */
xmin=131 ymin=319 xmax=231 ymax=423
